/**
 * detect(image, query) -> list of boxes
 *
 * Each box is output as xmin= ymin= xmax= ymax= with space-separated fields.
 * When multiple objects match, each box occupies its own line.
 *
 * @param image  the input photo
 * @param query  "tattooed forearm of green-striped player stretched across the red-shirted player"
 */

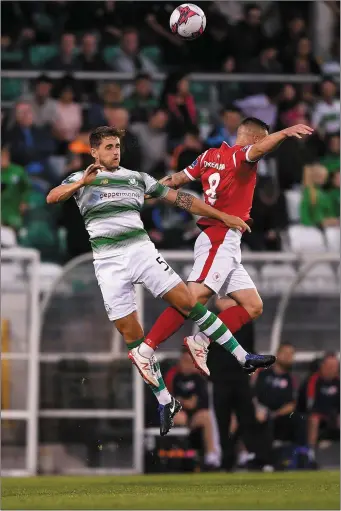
xmin=162 ymin=190 xmax=251 ymax=232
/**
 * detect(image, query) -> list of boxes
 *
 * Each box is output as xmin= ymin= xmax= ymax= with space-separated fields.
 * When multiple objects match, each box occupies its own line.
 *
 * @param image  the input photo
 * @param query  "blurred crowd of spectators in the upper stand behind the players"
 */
xmin=1 ymin=1 xmax=340 ymax=262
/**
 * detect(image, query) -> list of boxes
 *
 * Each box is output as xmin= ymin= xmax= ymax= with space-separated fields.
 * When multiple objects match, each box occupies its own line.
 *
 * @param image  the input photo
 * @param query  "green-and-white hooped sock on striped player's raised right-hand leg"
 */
xmin=189 ymin=303 xmax=247 ymax=364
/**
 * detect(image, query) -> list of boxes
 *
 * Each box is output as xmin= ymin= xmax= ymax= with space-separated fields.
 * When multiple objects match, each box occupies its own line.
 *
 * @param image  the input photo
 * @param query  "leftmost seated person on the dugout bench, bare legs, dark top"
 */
xmin=166 ymin=351 xmax=220 ymax=468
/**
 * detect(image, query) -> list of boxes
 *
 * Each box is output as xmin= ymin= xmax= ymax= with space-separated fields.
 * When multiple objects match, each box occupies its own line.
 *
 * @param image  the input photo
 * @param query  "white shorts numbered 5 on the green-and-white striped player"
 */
xmin=94 ymin=241 xmax=182 ymax=321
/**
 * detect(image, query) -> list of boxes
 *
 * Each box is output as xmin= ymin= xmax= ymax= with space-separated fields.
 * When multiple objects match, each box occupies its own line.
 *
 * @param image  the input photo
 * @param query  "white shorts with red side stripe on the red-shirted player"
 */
xmin=187 ymin=227 xmax=256 ymax=298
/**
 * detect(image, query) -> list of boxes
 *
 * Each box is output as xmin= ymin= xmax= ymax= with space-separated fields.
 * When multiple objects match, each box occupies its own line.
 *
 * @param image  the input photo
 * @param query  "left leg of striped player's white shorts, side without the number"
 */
xmin=94 ymin=255 xmax=137 ymax=321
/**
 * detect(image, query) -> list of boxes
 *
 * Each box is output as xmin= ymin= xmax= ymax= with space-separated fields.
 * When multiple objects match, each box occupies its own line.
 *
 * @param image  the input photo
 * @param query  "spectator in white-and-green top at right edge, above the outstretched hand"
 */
xmin=312 ymin=78 xmax=340 ymax=137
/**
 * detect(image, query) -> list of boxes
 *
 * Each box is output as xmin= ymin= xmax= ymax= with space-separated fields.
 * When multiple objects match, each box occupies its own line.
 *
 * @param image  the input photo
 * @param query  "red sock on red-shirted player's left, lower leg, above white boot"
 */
xmin=144 ymin=307 xmax=186 ymax=350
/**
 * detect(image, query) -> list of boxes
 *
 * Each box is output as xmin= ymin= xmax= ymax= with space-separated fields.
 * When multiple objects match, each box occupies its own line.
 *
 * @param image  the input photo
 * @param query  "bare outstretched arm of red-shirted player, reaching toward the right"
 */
xmin=247 ymin=124 xmax=314 ymax=162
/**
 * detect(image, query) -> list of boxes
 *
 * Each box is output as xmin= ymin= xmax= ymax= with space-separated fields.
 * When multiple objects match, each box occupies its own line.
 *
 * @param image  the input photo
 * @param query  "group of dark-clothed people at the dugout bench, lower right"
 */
xmin=146 ymin=343 xmax=340 ymax=470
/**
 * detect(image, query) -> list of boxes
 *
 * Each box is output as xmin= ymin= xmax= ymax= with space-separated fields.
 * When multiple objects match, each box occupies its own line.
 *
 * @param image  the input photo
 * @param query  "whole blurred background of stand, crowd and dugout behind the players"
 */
xmin=1 ymin=0 xmax=340 ymax=475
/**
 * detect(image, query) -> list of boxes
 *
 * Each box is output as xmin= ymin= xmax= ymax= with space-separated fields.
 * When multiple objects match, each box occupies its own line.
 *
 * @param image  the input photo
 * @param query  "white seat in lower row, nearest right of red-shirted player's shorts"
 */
xmin=260 ymin=263 xmax=296 ymax=295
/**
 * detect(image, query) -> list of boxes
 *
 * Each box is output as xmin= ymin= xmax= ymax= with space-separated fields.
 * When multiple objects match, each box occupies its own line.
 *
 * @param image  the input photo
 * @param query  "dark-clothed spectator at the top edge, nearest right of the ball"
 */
xmin=235 ymin=4 xmax=266 ymax=66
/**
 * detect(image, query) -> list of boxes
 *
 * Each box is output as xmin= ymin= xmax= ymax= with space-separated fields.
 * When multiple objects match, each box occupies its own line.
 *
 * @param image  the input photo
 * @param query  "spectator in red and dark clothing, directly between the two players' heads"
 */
xmin=160 ymin=71 xmax=198 ymax=150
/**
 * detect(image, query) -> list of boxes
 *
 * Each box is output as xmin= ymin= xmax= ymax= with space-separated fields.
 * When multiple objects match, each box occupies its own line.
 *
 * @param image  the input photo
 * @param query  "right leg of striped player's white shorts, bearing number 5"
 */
xmin=129 ymin=242 xmax=183 ymax=298
